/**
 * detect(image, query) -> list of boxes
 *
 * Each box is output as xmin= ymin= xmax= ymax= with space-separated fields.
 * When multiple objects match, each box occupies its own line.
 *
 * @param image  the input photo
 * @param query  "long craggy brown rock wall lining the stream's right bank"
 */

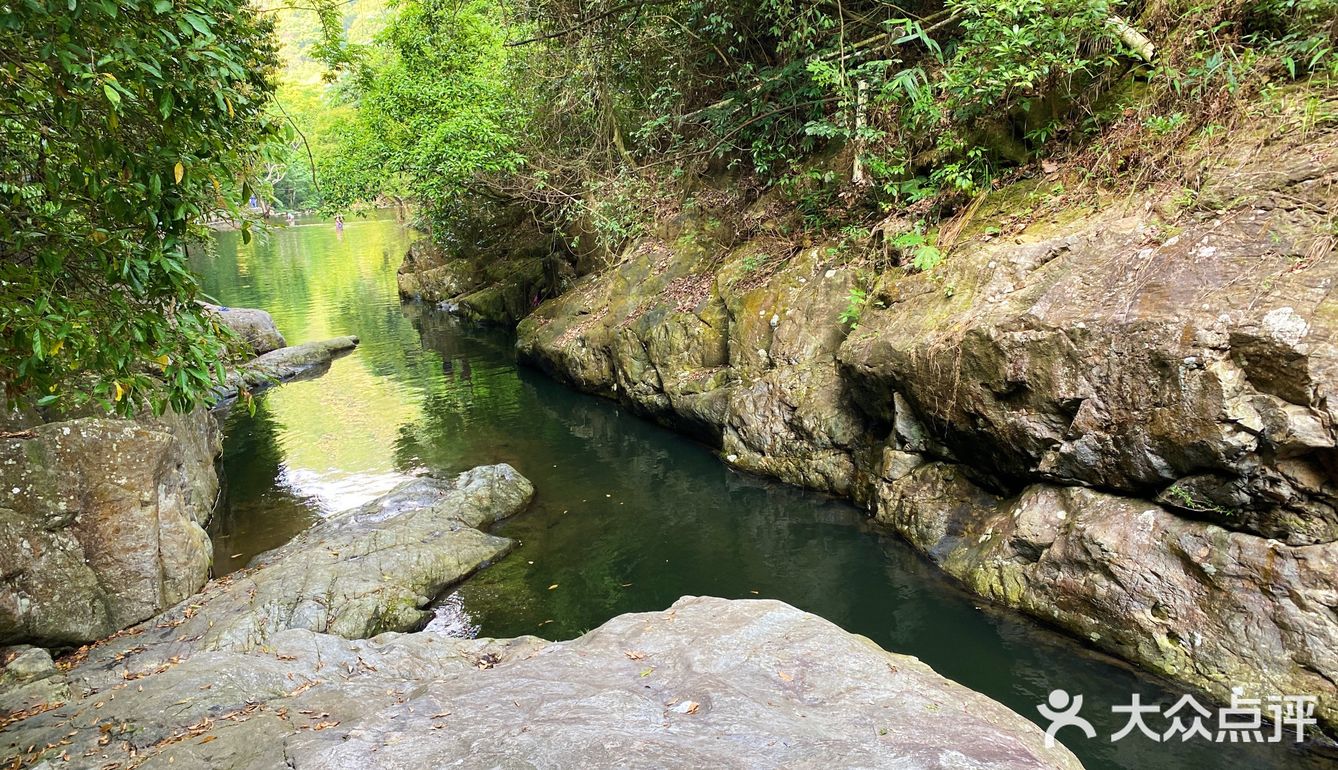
xmin=473 ymin=120 xmax=1338 ymax=727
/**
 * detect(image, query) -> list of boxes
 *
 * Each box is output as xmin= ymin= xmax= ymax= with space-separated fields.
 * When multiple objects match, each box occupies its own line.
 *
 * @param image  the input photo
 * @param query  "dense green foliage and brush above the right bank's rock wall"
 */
xmin=306 ymin=0 xmax=1338 ymax=269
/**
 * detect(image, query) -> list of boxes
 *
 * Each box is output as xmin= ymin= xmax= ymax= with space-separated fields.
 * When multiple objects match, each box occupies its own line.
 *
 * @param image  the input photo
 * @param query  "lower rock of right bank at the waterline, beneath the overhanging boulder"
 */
xmin=876 ymin=463 xmax=1338 ymax=726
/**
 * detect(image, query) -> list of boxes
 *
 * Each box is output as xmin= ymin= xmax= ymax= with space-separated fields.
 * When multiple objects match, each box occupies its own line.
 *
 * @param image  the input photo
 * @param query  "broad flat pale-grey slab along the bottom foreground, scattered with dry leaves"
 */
xmin=0 ymin=597 xmax=1080 ymax=769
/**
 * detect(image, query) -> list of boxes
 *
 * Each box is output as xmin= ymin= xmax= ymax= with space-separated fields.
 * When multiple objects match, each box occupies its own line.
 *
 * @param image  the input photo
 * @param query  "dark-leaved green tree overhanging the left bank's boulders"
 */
xmin=0 ymin=0 xmax=282 ymax=414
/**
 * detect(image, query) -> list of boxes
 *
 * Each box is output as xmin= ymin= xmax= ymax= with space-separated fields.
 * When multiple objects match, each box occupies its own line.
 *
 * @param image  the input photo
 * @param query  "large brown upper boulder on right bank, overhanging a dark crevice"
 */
xmin=839 ymin=207 xmax=1338 ymax=545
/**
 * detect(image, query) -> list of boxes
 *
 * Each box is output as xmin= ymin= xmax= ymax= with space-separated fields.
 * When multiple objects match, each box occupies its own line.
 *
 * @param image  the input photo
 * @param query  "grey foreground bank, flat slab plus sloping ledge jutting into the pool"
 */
xmin=0 ymin=466 xmax=1080 ymax=769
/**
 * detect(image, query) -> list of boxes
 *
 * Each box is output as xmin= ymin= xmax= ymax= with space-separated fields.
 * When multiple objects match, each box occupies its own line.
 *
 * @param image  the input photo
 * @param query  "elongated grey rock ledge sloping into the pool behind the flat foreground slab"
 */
xmin=100 ymin=465 xmax=534 ymax=659
